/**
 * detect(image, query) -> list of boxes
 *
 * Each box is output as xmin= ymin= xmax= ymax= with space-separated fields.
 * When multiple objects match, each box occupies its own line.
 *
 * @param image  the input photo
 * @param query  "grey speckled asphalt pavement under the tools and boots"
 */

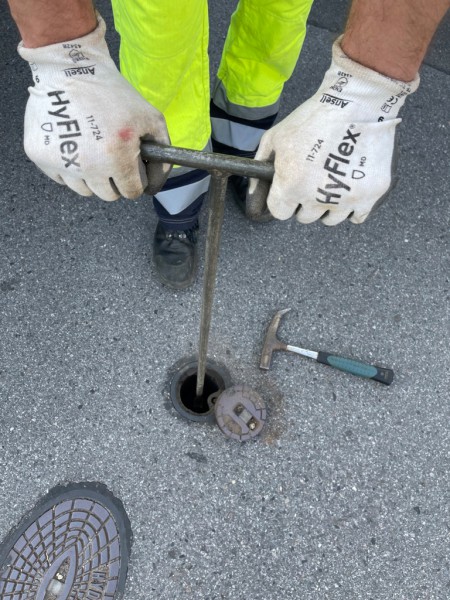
xmin=0 ymin=0 xmax=450 ymax=600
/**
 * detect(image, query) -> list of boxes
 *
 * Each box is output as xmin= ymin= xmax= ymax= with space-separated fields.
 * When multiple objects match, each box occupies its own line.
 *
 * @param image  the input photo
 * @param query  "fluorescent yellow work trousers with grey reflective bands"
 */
xmin=112 ymin=0 xmax=313 ymax=214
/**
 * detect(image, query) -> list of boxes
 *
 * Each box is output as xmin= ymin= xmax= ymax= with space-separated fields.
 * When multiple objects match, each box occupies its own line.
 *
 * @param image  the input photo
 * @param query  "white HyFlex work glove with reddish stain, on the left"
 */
xmin=18 ymin=15 xmax=170 ymax=200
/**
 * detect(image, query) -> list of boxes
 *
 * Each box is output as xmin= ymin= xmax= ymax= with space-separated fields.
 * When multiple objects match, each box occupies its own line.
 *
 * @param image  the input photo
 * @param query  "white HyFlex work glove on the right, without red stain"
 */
xmin=247 ymin=40 xmax=419 ymax=225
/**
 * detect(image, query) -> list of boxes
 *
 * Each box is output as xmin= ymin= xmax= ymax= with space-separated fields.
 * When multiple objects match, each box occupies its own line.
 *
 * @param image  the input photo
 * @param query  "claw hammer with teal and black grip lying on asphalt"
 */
xmin=259 ymin=308 xmax=394 ymax=385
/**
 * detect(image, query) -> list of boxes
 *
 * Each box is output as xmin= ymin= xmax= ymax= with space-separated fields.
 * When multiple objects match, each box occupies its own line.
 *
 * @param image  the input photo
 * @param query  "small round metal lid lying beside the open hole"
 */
xmin=214 ymin=385 xmax=267 ymax=442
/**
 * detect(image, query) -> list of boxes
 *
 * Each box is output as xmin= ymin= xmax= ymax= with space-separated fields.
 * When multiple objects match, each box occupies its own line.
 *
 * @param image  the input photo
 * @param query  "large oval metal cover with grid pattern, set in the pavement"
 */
xmin=0 ymin=482 xmax=132 ymax=600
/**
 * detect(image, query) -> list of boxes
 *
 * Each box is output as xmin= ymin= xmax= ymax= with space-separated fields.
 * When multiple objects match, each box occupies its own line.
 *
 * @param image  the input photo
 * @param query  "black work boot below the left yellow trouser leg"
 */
xmin=153 ymin=221 xmax=198 ymax=290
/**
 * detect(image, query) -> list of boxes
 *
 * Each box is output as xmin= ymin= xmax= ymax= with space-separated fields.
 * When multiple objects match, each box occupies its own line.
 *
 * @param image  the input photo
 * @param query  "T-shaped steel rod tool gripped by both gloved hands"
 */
xmin=141 ymin=142 xmax=274 ymax=397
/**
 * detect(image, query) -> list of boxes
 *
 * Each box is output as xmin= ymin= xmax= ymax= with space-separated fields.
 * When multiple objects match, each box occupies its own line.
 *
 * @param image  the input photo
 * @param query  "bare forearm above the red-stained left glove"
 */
xmin=8 ymin=0 xmax=97 ymax=48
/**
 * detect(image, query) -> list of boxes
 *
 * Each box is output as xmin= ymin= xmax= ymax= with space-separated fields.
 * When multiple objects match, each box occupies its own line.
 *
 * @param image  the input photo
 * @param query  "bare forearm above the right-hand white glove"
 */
xmin=341 ymin=0 xmax=450 ymax=81
